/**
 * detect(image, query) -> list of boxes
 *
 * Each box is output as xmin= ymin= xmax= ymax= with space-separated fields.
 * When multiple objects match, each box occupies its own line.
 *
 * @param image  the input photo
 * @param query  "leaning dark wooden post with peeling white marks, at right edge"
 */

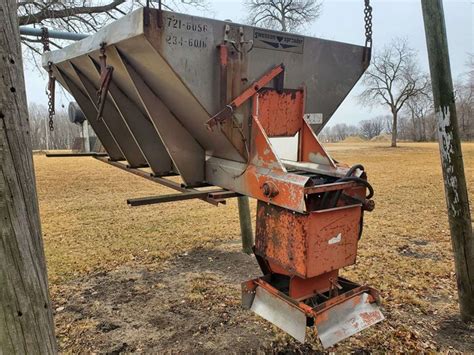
xmin=421 ymin=0 xmax=474 ymax=322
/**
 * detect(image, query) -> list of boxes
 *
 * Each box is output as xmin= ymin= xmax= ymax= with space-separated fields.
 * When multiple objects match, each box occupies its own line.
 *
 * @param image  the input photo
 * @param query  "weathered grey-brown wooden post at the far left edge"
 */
xmin=0 ymin=0 xmax=57 ymax=354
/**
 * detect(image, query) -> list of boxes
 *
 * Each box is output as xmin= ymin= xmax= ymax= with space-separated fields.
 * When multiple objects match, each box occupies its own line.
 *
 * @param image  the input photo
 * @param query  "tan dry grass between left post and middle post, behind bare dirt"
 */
xmin=35 ymin=156 xmax=248 ymax=285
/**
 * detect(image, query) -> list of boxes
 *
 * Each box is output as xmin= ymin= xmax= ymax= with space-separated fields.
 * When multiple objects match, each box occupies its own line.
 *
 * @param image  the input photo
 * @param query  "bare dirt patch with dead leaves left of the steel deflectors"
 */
xmin=55 ymin=244 xmax=286 ymax=353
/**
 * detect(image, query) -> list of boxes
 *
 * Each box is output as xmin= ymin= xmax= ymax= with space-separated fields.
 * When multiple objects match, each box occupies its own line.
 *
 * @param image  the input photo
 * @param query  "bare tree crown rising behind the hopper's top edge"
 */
xmin=245 ymin=0 xmax=322 ymax=32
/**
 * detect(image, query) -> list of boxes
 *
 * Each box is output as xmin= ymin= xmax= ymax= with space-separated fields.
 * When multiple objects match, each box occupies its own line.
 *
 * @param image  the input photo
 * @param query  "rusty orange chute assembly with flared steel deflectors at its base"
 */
xmin=224 ymin=66 xmax=384 ymax=347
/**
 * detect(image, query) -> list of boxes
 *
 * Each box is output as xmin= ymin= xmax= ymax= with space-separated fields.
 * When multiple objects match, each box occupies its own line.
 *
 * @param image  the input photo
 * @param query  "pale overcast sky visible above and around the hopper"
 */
xmin=25 ymin=0 xmax=474 ymax=124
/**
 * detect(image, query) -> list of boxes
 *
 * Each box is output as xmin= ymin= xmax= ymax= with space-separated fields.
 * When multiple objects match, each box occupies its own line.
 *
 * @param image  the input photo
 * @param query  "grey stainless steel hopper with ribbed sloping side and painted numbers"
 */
xmin=43 ymin=8 xmax=367 ymax=185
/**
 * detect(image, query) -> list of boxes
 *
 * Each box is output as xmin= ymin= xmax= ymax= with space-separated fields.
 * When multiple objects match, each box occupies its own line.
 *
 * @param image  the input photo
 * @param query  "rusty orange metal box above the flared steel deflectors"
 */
xmin=255 ymin=201 xmax=362 ymax=278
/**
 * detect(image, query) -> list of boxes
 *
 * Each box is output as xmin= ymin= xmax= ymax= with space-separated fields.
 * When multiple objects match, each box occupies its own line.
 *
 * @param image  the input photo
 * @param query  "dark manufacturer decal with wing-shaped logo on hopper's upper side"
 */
xmin=253 ymin=29 xmax=304 ymax=53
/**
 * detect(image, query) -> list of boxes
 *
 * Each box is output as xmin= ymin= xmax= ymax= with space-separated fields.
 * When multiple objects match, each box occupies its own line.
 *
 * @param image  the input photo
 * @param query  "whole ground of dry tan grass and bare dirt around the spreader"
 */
xmin=35 ymin=143 xmax=474 ymax=352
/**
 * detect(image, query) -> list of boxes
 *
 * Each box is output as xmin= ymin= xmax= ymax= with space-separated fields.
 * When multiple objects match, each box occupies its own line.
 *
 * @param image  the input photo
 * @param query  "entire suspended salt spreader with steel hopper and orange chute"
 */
xmin=43 ymin=2 xmax=383 ymax=347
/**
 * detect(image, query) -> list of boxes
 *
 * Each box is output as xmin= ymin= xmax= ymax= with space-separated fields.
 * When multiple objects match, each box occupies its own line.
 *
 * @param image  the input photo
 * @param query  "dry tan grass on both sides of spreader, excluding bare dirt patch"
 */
xmin=35 ymin=143 xmax=474 ymax=351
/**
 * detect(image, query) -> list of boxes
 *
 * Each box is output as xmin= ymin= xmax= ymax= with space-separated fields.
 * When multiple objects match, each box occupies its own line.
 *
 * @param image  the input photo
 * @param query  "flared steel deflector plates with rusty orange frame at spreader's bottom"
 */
xmin=242 ymin=277 xmax=385 ymax=349
